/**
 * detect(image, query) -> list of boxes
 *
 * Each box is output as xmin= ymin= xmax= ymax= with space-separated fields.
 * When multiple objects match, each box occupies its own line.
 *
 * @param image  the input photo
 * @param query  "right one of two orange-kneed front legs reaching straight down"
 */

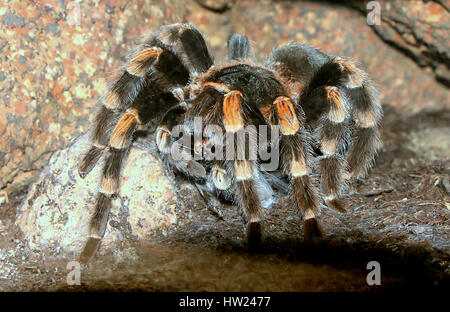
xmin=274 ymin=96 xmax=322 ymax=238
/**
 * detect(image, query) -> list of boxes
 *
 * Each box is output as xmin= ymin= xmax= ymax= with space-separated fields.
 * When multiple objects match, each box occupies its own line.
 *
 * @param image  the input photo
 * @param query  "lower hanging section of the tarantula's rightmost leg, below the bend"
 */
xmin=347 ymin=81 xmax=383 ymax=177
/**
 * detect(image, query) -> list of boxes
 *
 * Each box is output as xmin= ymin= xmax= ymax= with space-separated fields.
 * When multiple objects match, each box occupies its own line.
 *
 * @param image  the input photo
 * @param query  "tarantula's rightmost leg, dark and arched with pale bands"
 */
xmin=299 ymin=50 xmax=382 ymax=181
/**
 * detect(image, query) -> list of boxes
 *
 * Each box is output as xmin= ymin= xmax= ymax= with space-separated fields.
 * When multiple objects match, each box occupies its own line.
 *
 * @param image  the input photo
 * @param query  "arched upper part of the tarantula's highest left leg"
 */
xmin=104 ymin=24 xmax=213 ymax=109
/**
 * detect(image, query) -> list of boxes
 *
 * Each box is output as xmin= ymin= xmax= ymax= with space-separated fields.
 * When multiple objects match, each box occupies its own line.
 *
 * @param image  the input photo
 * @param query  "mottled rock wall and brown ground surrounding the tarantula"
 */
xmin=0 ymin=0 xmax=450 ymax=290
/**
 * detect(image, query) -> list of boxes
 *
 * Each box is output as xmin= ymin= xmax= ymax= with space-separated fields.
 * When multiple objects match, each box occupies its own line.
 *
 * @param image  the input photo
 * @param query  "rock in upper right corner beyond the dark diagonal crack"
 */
xmin=356 ymin=0 xmax=450 ymax=87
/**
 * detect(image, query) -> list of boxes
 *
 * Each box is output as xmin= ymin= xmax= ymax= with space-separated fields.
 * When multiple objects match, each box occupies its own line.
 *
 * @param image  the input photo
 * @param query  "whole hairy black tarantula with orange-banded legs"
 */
xmin=79 ymin=24 xmax=382 ymax=262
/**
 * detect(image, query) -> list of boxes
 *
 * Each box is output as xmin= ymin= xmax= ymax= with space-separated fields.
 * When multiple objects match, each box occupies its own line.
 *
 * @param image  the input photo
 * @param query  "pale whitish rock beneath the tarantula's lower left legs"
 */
xmin=16 ymin=135 xmax=177 ymax=254
